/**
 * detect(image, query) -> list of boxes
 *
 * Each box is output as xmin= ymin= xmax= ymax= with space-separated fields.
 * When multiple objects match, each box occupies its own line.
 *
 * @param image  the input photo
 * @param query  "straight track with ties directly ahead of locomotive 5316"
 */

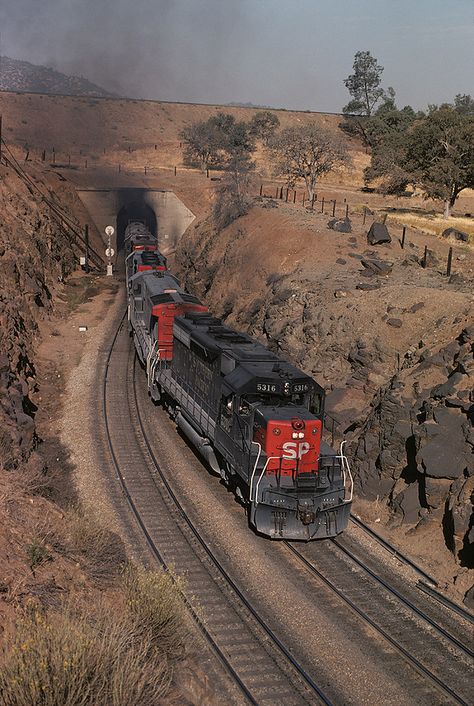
xmin=285 ymin=539 xmax=474 ymax=706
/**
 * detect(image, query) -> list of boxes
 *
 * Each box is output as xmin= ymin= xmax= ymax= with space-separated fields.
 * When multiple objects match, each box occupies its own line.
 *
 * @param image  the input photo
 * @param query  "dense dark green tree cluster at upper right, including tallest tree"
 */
xmin=341 ymin=51 xmax=474 ymax=217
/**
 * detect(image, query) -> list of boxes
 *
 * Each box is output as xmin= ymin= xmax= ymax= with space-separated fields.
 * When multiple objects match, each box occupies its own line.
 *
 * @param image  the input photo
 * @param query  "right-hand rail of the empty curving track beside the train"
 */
xmin=133 ymin=357 xmax=332 ymax=706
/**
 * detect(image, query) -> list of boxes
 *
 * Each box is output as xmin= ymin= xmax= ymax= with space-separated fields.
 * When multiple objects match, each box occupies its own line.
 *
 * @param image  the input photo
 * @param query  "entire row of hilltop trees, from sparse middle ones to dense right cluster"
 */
xmin=180 ymin=51 xmax=474 ymax=224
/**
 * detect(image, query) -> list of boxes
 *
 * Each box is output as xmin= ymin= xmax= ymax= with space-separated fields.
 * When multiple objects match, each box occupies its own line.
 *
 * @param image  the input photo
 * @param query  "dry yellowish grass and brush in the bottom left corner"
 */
xmin=0 ymin=568 xmax=186 ymax=706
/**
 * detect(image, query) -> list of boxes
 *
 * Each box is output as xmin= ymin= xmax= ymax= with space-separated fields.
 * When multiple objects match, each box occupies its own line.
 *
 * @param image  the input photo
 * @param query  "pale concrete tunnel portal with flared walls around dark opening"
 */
xmin=77 ymin=187 xmax=195 ymax=255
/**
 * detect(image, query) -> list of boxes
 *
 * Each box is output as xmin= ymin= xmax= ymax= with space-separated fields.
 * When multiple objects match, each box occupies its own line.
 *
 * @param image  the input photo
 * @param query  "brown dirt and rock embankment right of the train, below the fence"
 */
xmin=177 ymin=199 xmax=474 ymax=595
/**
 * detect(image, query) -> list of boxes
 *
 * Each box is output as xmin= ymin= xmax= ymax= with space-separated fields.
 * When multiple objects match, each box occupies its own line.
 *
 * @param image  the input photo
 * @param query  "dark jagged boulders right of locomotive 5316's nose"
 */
xmin=355 ymin=326 xmax=474 ymax=566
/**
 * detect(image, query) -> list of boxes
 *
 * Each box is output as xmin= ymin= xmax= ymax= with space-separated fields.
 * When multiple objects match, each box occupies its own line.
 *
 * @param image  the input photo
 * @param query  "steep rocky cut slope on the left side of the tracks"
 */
xmin=0 ymin=168 xmax=74 ymax=469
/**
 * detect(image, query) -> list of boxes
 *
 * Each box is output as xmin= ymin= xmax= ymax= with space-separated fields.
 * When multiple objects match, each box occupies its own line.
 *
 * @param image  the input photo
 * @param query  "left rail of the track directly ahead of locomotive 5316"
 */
xmin=283 ymin=540 xmax=470 ymax=706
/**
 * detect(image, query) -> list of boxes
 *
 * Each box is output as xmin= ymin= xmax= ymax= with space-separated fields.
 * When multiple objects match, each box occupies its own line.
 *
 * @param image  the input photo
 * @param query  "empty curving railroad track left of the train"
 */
xmin=102 ymin=317 xmax=331 ymax=706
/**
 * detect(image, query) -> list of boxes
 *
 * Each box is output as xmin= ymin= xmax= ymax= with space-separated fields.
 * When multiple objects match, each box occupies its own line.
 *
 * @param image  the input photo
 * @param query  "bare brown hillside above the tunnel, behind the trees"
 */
xmin=0 ymin=92 xmax=367 ymax=183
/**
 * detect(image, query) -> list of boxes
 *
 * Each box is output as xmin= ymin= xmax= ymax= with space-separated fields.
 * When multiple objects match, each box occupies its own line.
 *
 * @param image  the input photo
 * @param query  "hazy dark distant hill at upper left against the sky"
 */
xmin=0 ymin=56 xmax=118 ymax=98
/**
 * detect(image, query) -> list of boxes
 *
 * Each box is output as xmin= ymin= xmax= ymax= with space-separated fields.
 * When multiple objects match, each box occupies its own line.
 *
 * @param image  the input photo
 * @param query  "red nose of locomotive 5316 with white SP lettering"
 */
xmin=255 ymin=417 xmax=322 ymax=476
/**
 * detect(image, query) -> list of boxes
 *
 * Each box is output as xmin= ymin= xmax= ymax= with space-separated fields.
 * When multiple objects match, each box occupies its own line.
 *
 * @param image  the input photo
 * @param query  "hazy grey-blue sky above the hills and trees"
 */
xmin=0 ymin=0 xmax=474 ymax=112
